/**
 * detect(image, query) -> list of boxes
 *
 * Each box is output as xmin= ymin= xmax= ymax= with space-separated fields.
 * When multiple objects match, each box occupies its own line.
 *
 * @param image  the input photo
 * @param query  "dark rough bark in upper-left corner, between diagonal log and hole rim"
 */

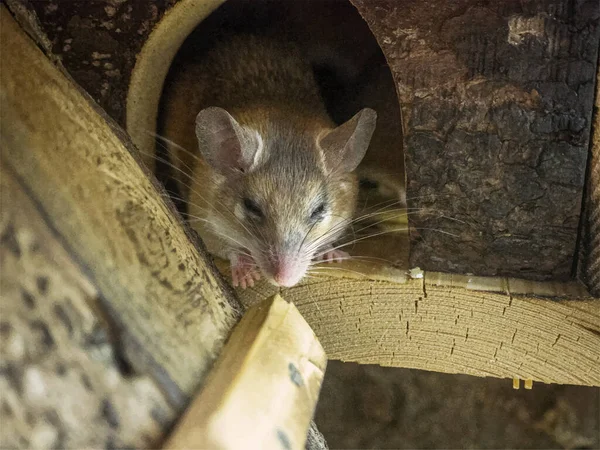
xmin=8 ymin=0 xmax=176 ymax=126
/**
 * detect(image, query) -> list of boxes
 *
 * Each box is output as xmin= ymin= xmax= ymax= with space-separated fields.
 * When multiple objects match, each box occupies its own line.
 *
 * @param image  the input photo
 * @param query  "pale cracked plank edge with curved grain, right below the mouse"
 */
xmin=213 ymin=265 xmax=600 ymax=386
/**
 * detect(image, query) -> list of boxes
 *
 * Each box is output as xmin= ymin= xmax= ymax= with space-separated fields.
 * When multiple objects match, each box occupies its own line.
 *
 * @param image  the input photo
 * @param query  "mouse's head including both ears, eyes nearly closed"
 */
xmin=196 ymin=107 xmax=376 ymax=286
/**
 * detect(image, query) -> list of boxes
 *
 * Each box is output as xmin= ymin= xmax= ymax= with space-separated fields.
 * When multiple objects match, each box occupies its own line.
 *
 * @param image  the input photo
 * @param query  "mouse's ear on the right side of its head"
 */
xmin=319 ymin=108 xmax=377 ymax=172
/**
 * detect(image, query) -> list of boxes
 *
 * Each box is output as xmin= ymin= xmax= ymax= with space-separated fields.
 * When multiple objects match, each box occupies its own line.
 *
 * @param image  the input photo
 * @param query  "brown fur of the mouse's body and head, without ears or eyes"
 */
xmin=162 ymin=36 xmax=370 ymax=284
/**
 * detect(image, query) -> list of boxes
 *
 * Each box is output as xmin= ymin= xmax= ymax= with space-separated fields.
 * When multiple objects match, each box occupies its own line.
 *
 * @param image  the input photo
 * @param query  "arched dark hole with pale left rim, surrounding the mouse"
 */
xmin=127 ymin=0 xmax=408 ymax=268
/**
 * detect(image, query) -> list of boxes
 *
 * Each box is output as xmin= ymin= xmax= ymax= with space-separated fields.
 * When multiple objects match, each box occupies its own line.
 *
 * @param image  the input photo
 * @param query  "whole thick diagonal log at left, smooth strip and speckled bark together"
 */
xmin=0 ymin=6 xmax=241 ymax=447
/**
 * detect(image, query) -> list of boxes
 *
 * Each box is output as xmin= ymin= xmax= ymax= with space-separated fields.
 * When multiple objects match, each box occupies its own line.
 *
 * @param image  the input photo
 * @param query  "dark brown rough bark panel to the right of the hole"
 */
xmin=351 ymin=0 xmax=600 ymax=279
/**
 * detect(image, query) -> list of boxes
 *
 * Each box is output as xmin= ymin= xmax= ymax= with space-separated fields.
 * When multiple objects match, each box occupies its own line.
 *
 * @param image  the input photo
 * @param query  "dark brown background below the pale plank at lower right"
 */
xmin=315 ymin=361 xmax=600 ymax=449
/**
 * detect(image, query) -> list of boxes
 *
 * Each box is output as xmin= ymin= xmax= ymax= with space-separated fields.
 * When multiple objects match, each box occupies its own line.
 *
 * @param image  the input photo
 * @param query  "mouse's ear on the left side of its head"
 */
xmin=196 ymin=107 xmax=259 ymax=173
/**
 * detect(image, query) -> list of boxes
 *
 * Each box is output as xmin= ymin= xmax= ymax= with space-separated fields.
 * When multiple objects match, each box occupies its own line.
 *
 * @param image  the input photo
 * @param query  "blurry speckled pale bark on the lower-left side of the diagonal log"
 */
xmin=0 ymin=162 xmax=176 ymax=449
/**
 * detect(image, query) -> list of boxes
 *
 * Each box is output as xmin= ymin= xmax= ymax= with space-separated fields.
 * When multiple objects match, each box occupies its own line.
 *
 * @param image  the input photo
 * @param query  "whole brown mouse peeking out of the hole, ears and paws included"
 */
xmin=160 ymin=35 xmax=377 ymax=288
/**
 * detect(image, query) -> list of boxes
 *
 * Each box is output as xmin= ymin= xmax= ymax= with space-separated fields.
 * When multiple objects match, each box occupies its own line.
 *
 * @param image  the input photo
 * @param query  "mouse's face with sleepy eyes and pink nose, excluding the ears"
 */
xmin=233 ymin=152 xmax=357 ymax=286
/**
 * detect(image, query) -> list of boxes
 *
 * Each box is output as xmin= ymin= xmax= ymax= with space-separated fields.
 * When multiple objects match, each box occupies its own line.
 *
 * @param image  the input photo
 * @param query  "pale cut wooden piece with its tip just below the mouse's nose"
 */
xmin=165 ymin=295 xmax=327 ymax=450
